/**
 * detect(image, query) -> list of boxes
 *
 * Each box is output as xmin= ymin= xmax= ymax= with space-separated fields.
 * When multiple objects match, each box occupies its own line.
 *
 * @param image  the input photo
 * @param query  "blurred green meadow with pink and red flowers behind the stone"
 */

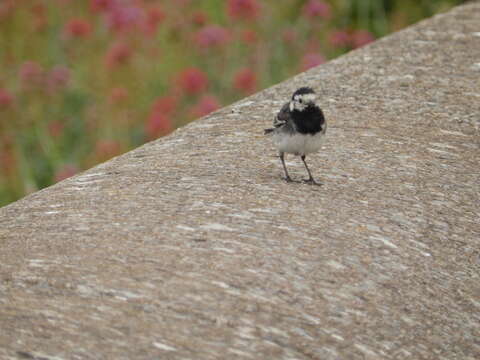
xmin=0 ymin=0 xmax=462 ymax=206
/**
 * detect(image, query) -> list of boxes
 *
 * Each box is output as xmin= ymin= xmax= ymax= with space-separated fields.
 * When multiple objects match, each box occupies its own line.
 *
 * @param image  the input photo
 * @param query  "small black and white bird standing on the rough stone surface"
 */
xmin=265 ymin=87 xmax=327 ymax=185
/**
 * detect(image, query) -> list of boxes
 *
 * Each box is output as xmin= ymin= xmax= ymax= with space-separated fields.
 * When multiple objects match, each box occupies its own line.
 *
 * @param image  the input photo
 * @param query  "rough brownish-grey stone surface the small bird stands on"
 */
xmin=0 ymin=3 xmax=480 ymax=360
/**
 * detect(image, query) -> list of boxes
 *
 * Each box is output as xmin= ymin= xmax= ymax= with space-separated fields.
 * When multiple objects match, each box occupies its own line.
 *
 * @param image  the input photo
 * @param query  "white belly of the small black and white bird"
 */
xmin=273 ymin=132 xmax=324 ymax=155
